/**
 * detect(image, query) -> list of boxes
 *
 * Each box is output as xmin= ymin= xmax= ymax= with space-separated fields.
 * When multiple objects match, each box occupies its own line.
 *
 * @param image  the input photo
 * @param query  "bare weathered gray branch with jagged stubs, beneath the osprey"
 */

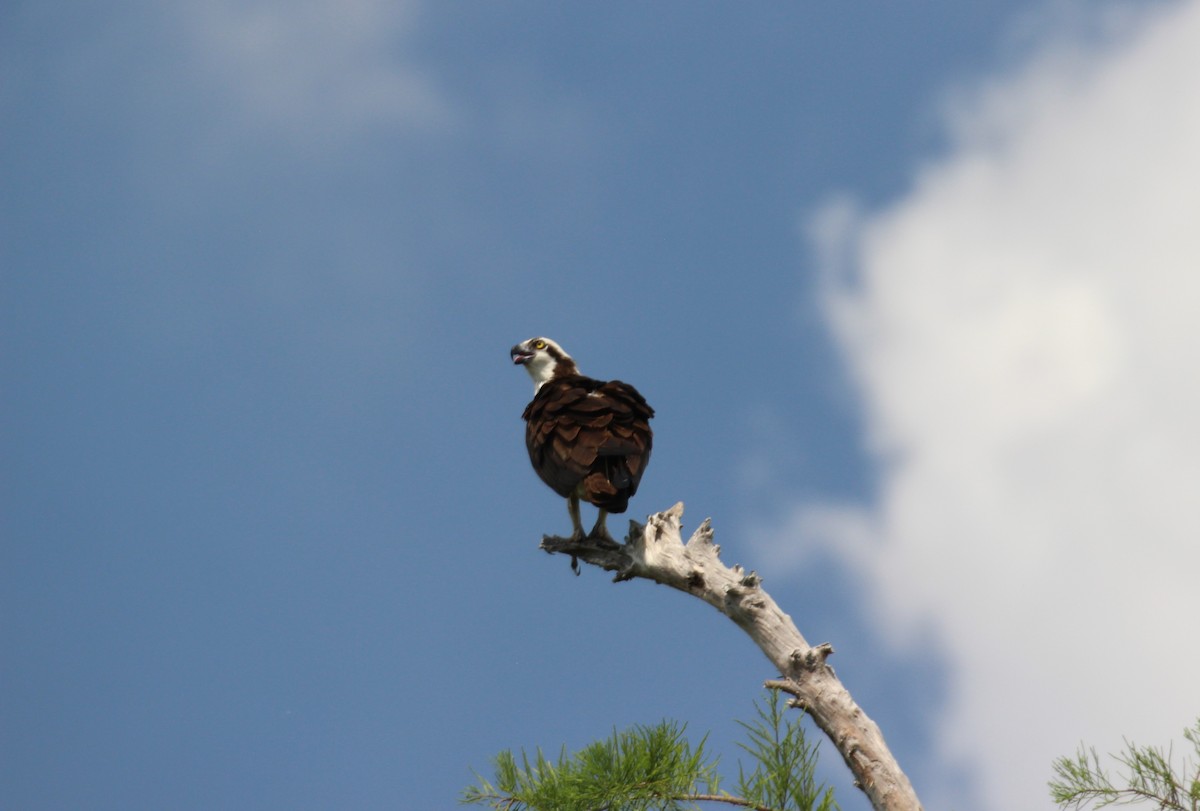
xmin=541 ymin=503 xmax=920 ymax=811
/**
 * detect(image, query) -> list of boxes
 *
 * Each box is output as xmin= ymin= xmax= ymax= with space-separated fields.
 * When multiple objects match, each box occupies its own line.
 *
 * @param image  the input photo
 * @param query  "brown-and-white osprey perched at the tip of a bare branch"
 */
xmin=511 ymin=338 xmax=654 ymax=541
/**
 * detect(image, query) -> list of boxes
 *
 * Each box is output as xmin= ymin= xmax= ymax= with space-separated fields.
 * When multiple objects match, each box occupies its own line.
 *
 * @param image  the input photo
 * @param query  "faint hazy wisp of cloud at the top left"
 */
xmin=188 ymin=0 xmax=451 ymax=140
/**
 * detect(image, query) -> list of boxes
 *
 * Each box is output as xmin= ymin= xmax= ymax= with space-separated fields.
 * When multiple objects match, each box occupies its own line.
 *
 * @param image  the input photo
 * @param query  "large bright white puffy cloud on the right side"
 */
xmin=781 ymin=1 xmax=1200 ymax=810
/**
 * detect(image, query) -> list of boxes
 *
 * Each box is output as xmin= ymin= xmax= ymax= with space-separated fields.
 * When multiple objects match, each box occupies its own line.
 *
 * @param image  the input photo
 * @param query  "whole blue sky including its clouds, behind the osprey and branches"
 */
xmin=0 ymin=0 xmax=1200 ymax=810
